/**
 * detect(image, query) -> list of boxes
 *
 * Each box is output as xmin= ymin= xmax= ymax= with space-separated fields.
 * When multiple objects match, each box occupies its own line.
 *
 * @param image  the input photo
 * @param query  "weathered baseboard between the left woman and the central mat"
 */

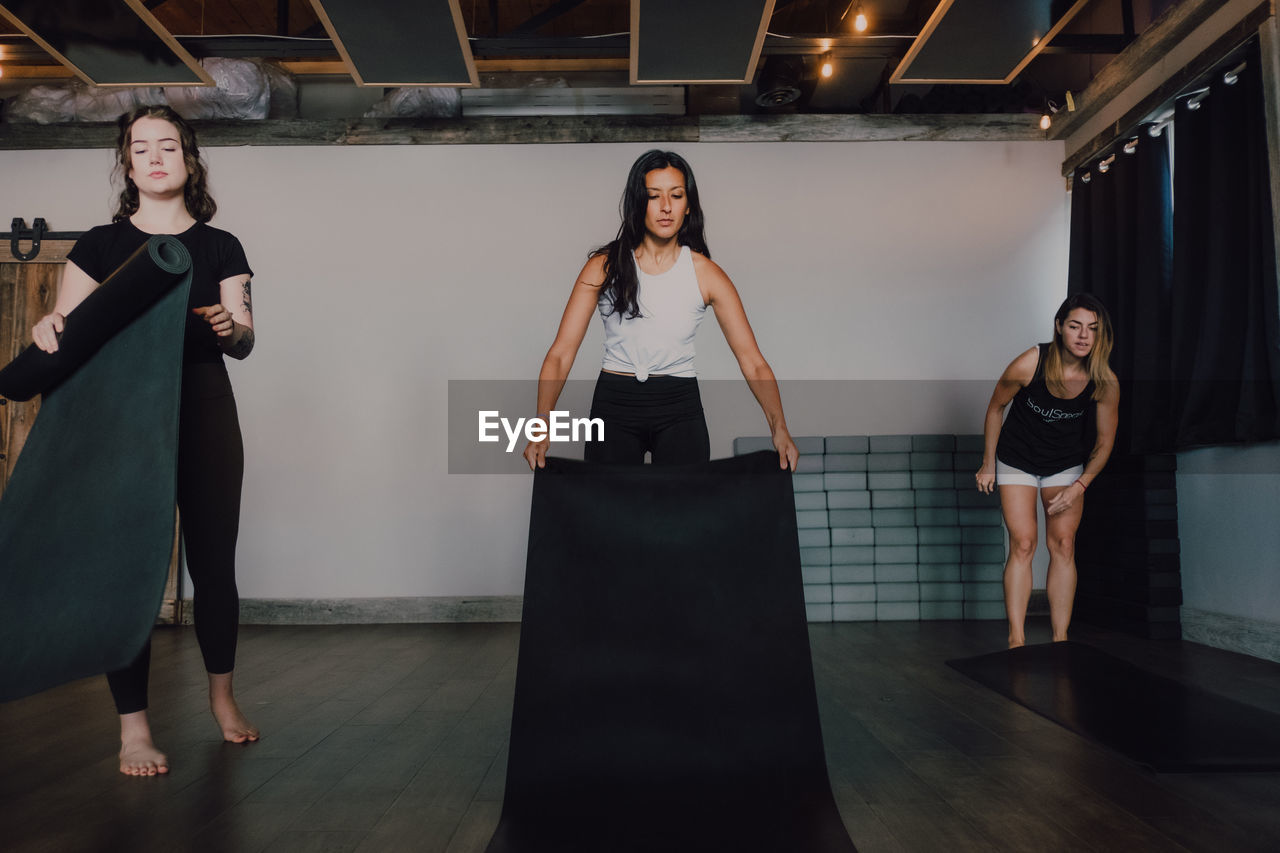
xmin=182 ymin=596 xmax=524 ymax=625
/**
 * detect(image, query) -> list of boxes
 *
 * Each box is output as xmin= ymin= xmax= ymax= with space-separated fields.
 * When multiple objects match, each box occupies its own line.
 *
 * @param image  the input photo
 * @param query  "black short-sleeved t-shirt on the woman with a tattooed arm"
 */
xmin=67 ymin=219 xmax=253 ymax=364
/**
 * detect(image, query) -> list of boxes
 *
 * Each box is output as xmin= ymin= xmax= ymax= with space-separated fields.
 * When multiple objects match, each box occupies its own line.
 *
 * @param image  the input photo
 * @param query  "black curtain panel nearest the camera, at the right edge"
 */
xmin=1170 ymin=46 xmax=1280 ymax=447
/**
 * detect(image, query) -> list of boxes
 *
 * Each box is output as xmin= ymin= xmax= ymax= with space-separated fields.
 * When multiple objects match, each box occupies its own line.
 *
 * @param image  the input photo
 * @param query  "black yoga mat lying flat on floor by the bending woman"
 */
xmin=947 ymin=642 xmax=1280 ymax=772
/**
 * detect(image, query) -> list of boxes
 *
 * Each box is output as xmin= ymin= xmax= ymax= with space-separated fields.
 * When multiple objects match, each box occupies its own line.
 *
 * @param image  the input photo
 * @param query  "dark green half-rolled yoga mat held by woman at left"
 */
xmin=0 ymin=237 xmax=191 ymax=701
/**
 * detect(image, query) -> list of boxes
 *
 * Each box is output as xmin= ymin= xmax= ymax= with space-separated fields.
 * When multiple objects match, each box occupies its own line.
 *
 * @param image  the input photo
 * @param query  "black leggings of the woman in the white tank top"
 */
xmin=582 ymin=370 xmax=712 ymax=465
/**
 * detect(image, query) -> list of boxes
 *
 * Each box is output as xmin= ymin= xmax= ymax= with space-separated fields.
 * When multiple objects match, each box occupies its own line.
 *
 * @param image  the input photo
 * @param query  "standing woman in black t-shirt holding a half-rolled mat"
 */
xmin=32 ymin=106 xmax=259 ymax=776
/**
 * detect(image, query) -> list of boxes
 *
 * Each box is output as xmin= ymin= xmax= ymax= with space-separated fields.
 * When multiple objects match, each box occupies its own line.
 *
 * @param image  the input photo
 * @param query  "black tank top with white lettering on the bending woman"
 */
xmin=996 ymin=343 xmax=1096 ymax=476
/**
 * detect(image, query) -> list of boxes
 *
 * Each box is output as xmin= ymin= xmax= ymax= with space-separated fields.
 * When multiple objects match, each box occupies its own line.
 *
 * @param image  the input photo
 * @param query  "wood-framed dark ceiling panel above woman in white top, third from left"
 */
xmin=631 ymin=0 xmax=774 ymax=83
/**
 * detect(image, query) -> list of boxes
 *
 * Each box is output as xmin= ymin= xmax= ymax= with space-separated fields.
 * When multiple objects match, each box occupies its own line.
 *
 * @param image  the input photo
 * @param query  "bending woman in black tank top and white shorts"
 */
xmin=975 ymin=293 xmax=1120 ymax=648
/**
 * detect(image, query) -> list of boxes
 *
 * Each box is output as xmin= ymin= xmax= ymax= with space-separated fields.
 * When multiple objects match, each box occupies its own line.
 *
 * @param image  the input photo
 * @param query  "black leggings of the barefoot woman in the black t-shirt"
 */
xmin=106 ymin=364 xmax=244 ymax=713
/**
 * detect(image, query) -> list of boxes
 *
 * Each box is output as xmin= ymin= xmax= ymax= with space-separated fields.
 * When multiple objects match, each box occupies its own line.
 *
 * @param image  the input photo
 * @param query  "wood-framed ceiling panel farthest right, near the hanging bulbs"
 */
xmin=890 ymin=0 xmax=1088 ymax=83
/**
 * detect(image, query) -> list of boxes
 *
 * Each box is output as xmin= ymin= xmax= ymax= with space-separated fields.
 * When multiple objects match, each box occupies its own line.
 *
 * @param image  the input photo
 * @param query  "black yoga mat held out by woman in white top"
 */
xmin=488 ymin=452 xmax=854 ymax=853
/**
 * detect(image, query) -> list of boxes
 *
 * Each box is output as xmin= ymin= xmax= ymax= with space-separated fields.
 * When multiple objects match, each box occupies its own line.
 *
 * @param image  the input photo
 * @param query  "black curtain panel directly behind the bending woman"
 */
xmin=1068 ymin=129 xmax=1174 ymax=452
